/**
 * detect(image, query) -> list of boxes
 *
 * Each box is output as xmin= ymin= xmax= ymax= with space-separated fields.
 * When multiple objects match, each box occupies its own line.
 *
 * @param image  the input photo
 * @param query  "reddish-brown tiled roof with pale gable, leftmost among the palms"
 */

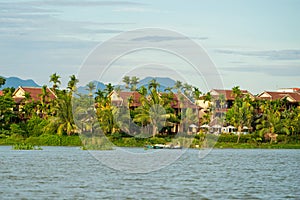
xmin=13 ymin=86 xmax=56 ymax=103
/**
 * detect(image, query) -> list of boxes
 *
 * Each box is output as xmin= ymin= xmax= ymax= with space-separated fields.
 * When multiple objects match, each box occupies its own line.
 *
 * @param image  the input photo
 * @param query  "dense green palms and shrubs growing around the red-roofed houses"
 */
xmin=0 ymin=73 xmax=300 ymax=149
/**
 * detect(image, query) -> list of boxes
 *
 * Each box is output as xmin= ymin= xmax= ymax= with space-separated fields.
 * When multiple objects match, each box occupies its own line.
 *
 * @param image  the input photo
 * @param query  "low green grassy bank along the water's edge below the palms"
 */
xmin=0 ymin=134 xmax=300 ymax=149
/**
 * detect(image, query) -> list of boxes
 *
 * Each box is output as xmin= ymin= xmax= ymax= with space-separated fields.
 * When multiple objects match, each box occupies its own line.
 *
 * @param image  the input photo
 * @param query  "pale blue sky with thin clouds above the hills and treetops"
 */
xmin=0 ymin=0 xmax=300 ymax=94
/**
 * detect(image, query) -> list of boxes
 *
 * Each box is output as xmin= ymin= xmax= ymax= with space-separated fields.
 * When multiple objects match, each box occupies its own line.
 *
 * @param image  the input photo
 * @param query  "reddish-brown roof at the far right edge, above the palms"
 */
xmin=257 ymin=91 xmax=300 ymax=102
